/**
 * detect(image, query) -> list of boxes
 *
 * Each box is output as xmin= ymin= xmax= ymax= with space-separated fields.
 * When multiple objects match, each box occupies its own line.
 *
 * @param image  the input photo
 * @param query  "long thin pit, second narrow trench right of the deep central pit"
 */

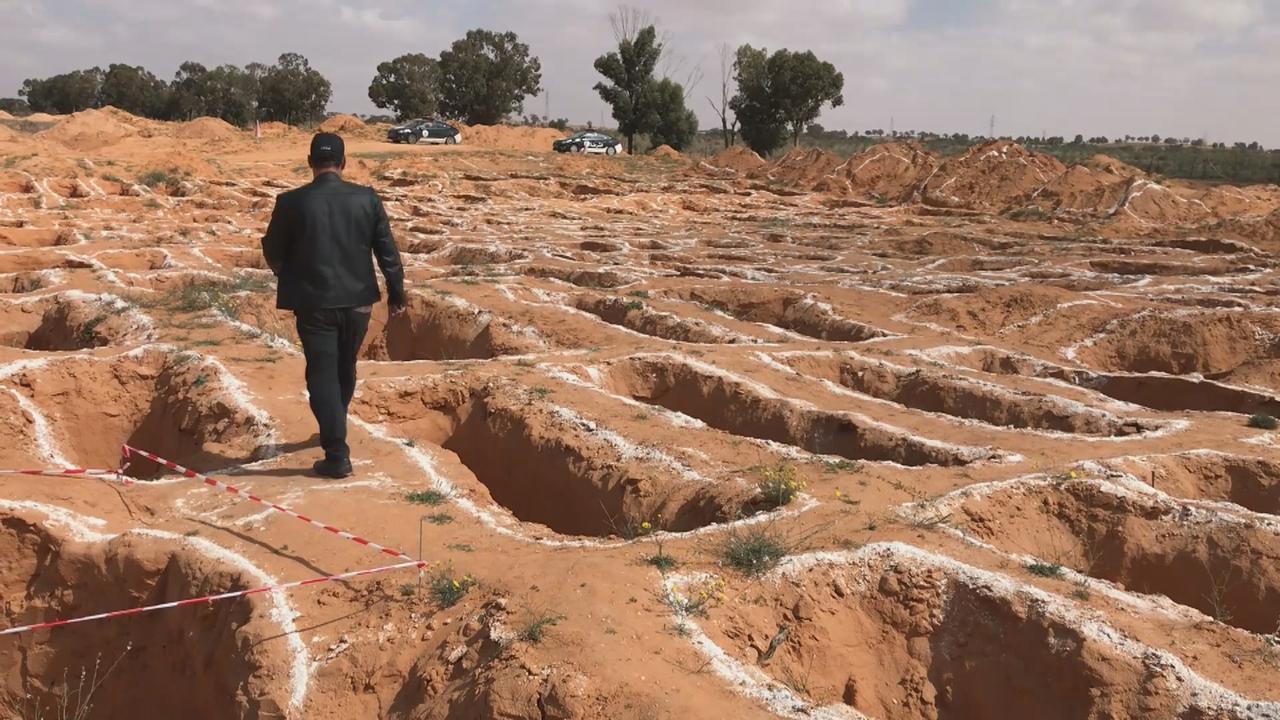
xmin=780 ymin=354 xmax=1155 ymax=437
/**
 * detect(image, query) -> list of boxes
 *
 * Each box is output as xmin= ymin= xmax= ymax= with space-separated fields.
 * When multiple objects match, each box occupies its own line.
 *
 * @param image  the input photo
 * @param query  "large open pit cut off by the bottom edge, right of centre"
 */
xmin=713 ymin=543 xmax=1263 ymax=720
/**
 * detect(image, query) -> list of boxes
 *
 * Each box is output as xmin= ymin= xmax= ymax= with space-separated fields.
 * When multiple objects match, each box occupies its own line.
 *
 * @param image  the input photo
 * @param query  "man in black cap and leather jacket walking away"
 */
xmin=262 ymin=132 xmax=404 ymax=478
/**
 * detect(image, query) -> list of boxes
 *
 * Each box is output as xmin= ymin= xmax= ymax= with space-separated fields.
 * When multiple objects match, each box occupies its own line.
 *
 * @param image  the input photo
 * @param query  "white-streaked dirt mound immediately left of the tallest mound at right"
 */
xmin=824 ymin=142 xmax=940 ymax=202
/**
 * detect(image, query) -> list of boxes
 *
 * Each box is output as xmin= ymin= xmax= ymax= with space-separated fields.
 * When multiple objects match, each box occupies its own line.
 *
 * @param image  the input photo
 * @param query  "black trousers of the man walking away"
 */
xmin=294 ymin=307 xmax=369 ymax=460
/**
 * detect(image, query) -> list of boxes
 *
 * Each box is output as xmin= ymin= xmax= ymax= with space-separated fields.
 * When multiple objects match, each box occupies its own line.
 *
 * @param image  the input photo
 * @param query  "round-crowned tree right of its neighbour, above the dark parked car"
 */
xmin=439 ymin=29 xmax=543 ymax=126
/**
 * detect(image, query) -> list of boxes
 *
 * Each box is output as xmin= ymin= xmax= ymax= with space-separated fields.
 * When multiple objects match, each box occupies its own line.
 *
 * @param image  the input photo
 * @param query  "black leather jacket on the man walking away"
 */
xmin=262 ymin=173 xmax=404 ymax=310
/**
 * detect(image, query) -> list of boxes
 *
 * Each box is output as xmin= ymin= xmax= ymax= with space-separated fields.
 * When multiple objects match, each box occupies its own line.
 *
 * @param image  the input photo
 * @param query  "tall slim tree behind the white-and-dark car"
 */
xmin=595 ymin=24 xmax=665 ymax=152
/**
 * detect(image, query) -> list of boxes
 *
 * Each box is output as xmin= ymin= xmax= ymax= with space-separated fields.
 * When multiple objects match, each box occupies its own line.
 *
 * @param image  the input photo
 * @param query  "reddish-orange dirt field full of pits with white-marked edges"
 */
xmin=0 ymin=110 xmax=1280 ymax=720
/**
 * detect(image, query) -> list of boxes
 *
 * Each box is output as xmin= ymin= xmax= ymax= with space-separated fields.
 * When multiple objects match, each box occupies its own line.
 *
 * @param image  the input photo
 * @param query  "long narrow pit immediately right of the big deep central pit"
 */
xmin=608 ymin=356 xmax=993 ymax=466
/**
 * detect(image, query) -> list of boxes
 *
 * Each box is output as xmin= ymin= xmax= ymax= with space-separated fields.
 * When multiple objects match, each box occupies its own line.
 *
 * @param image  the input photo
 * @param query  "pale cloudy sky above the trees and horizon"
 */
xmin=0 ymin=0 xmax=1280 ymax=147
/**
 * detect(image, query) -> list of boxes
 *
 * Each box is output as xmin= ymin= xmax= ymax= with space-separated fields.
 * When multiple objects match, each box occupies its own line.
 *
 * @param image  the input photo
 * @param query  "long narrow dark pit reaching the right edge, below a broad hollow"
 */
xmin=947 ymin=347 xmax=1280 ymax=416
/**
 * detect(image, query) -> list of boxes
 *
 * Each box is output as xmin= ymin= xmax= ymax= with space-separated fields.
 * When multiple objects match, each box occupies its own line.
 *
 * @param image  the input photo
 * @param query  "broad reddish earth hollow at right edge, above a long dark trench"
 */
xmin=1076 ymin=314 xmax=1280 ymax=375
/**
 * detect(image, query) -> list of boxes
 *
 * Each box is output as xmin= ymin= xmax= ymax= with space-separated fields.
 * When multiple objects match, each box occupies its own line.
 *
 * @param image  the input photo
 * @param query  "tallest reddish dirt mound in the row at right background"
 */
xmin=923 ymin=140 xmax=1066 ymax=210
